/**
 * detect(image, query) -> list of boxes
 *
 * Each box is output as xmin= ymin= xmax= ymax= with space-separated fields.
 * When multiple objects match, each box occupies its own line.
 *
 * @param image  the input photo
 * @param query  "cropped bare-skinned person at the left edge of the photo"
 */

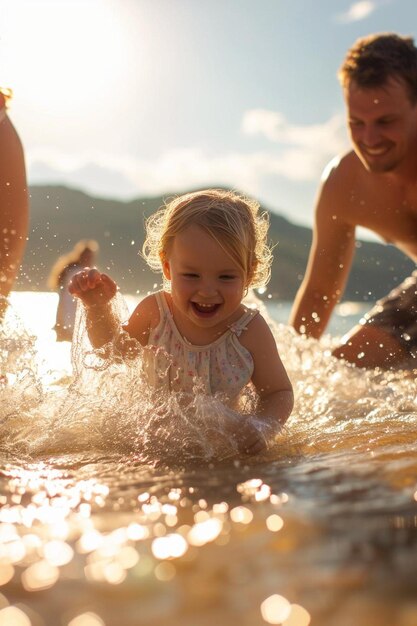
xmin=0 ymin=88 xmax=29 ymax=319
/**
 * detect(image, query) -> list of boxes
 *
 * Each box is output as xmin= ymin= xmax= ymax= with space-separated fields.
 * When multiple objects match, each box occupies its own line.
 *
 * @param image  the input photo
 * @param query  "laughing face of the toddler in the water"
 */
xmin=163 ymin=224 xmax=247 ymax=341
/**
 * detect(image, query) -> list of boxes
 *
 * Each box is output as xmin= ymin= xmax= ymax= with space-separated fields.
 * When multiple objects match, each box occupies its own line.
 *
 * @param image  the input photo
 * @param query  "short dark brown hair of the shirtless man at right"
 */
xmin=338 ymin=33 xmax=417 ymax=104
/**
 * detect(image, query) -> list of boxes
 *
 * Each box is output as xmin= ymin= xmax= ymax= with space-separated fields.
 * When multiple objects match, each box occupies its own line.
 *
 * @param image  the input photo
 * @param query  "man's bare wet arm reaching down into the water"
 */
xmin=290 ymin=161 xmax=355 ymax=338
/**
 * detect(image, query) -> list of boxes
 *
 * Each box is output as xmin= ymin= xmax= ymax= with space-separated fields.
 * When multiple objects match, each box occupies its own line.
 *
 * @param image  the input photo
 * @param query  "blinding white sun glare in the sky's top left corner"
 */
xmin=0 ymin=0 xmax=129 ymax=115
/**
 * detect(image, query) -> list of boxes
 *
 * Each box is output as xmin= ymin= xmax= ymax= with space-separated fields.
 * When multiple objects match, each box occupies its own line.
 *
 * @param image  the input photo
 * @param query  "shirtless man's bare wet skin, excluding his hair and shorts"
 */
xmin=290 ymin=78 xmax=417 ymax=367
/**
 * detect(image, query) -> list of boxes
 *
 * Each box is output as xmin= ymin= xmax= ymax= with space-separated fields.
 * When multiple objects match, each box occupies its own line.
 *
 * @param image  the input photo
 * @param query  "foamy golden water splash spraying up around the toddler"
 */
xmin=0 ymin=295 xmax=417 ymax=472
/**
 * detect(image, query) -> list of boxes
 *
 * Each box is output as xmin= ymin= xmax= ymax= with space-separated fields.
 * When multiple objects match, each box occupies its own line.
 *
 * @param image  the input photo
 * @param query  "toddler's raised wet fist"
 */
xmin=68 ymin=267 xmax=117 ymax=306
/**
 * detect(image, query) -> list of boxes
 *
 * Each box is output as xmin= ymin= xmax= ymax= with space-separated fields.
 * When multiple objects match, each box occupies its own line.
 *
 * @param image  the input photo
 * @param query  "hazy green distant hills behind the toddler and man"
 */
xmin=16 ymin=186 xmax=415 ymax=301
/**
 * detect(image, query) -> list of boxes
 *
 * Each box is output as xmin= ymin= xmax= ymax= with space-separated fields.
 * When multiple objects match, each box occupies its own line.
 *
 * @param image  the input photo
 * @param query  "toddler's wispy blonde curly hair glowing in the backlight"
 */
xmin=142 ymin=189 xmax=273 ymax=288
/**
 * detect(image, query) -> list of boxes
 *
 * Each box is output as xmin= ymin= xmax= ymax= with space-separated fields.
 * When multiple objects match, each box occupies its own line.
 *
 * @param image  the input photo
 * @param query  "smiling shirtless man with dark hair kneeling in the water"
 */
xmin=290 ymin=34 xmax=417 ymax=368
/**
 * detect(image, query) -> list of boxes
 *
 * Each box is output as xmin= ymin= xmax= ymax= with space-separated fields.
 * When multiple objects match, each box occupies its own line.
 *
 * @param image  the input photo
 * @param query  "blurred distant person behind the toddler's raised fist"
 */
xmin=48 ymin=239 xmax=99 ymax=341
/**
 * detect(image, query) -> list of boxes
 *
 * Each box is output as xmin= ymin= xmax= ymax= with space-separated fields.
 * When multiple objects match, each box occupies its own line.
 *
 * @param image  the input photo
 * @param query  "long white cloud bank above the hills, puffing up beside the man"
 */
xmin=27 ymin=109 xmax=348 ymax=198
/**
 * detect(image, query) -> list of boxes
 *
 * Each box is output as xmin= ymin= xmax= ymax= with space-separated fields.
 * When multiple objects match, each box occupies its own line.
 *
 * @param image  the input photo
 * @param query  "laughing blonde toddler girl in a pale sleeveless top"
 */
xmin=69 ymin=189 xmax=293 ymax=454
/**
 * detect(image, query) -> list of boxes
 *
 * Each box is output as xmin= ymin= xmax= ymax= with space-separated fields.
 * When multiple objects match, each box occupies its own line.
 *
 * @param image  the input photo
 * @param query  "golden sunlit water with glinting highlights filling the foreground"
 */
xmin=0 ymin=293 xmax=417 ymax=626
